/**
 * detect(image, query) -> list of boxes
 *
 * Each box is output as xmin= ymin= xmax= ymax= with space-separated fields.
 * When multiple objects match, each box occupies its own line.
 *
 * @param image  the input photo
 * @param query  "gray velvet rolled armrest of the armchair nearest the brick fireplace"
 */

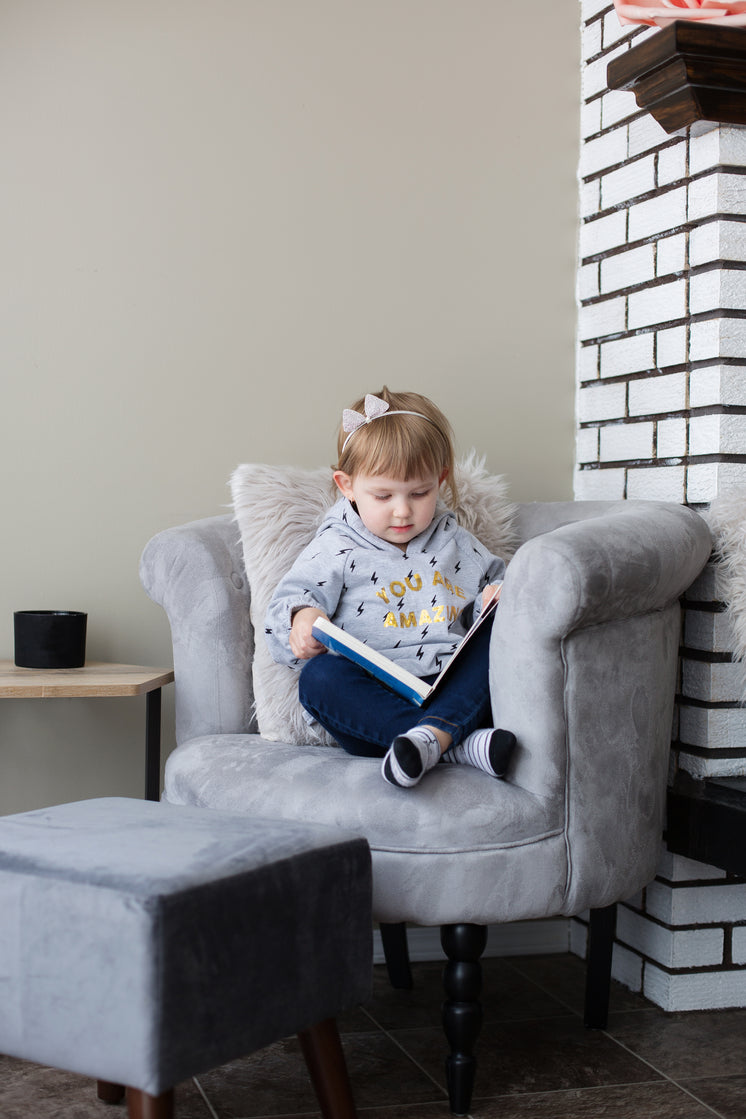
xmin=490 ymin=501 xmax=711 ymax=912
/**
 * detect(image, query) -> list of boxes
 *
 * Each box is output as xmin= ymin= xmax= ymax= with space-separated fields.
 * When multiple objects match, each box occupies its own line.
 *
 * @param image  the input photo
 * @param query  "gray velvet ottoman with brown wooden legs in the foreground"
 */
xmin=0 ymin=798 xmax=372 ymax=1119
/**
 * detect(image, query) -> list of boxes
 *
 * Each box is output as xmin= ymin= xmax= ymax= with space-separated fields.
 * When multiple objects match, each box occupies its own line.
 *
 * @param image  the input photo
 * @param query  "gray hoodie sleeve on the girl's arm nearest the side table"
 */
xmin=264 ymin=532 xmax=344 ymax=668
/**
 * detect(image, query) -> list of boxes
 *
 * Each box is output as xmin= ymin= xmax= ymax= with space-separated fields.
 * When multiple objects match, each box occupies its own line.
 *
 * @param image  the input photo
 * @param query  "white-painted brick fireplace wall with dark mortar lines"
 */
xmin=573 ymin=0 xmax=746 ymax=1009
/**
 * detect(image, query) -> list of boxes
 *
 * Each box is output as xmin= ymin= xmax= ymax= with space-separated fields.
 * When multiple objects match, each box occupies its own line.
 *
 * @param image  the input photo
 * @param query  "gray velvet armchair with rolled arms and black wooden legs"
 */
xmin=141 ymin=501 xmax=711 ymax=1115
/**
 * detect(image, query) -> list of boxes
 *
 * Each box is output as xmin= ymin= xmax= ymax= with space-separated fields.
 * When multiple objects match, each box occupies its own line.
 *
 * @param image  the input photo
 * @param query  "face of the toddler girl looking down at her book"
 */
xmin=334 ymin=470 xmax=445 ymax=551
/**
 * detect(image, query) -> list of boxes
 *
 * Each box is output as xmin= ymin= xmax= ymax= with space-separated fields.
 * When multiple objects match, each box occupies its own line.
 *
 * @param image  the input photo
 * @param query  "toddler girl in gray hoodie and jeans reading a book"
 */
xmin=265 ymin=387 xmax=516 ymax=788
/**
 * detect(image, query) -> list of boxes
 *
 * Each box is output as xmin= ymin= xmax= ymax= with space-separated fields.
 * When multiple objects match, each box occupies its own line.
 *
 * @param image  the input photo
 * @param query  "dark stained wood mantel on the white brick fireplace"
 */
xmin=606 ymin=20 xmax=746 ymax=132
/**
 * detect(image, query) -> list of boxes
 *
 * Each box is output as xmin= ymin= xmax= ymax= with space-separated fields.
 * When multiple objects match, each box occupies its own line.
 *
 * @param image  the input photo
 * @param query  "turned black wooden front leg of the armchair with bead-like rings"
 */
xmin=441 ymin=924 xmax=487 ymax=1116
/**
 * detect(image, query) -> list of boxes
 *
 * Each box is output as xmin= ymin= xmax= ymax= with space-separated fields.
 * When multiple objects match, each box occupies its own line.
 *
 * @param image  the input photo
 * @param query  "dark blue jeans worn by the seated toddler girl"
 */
xmin=298 ymin=621 xmax=492 ymax=758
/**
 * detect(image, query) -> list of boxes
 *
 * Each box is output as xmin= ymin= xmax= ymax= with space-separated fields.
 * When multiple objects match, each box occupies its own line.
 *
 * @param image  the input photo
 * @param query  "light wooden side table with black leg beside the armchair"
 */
xmin=0 ymin=660 xmax=173 ymax=800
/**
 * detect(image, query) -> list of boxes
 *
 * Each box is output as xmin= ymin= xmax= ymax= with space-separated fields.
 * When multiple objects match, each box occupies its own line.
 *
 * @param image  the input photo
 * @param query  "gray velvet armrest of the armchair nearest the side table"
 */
xmin=140 ymin=515 xmax=256 ymax=744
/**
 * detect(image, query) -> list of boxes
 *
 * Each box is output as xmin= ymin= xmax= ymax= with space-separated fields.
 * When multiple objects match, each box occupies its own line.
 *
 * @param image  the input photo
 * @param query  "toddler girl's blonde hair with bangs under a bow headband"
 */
xmin=336 ymin=385 xmax=459 ymax=506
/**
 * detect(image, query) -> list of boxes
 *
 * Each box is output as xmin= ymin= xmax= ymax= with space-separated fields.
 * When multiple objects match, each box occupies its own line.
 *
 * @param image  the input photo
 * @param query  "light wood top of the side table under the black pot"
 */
xmin=0 ymin=660 xmax=173 ymax=699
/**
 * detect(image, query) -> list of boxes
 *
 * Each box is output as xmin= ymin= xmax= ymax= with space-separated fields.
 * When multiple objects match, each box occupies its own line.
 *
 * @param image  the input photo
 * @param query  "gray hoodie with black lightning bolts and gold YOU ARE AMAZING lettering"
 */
xmin=265 ymin=498 xmax=506 ymax=676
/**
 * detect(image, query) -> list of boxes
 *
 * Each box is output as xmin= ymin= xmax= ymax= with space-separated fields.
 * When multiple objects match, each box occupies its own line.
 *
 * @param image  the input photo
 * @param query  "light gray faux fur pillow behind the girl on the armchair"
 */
xmin=230 ymin=451 xmax=517 ymax=745
